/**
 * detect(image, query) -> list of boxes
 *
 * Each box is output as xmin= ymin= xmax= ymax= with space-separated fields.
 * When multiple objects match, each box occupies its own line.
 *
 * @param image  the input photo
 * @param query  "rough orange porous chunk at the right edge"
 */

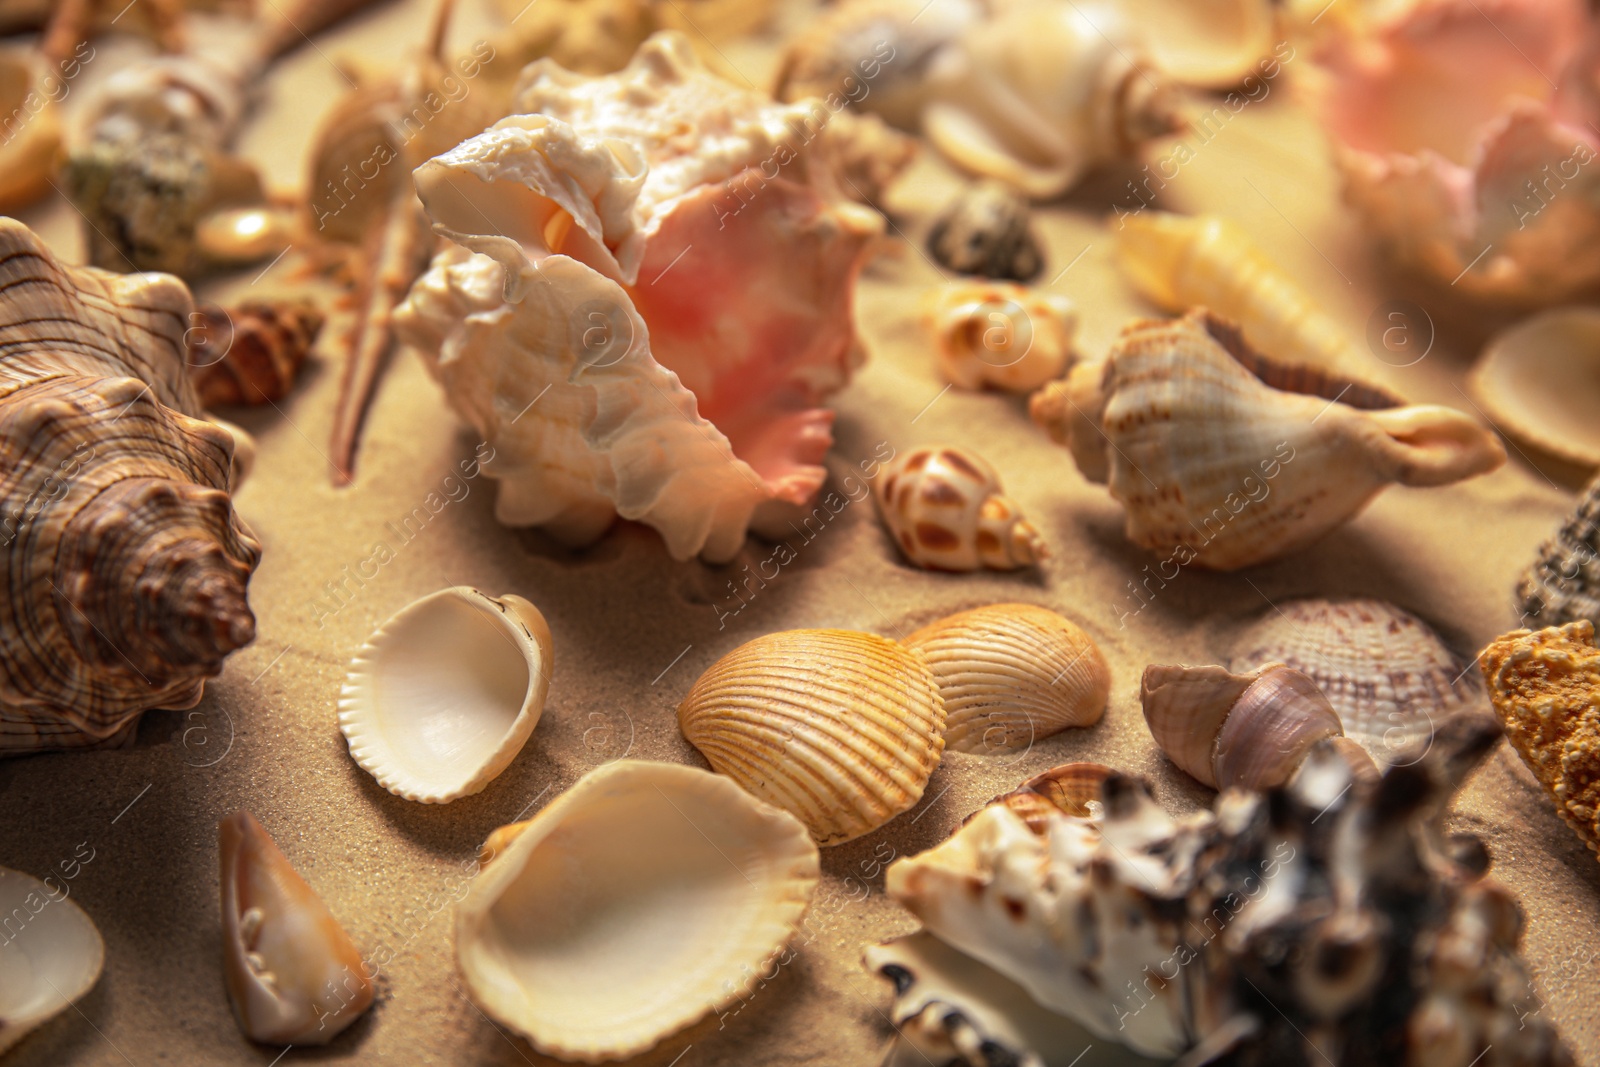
xmin=1478 ymin=619 xmax=1600 ymax=853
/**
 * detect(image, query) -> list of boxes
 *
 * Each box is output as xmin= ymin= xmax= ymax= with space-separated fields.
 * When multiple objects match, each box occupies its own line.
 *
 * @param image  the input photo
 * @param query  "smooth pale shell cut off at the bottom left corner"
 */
xmin=0 ymin=867 xmax=106 ymax=1054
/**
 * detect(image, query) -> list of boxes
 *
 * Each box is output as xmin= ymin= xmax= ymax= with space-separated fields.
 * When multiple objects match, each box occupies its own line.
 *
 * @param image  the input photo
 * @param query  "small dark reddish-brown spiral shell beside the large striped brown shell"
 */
xmin=184 ymin=301 xmax=323 ymax=408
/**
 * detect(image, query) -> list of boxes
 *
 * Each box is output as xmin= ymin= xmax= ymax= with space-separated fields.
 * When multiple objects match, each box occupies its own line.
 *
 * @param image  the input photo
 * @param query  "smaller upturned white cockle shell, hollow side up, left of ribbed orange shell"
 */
xmin=339 ymin=585 xmax=554 ymax=805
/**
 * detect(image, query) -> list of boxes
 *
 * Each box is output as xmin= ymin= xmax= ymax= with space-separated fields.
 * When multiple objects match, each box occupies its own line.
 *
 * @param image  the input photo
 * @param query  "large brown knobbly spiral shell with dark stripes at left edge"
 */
xmin=0 ymin=219 xmax=261 ymax=755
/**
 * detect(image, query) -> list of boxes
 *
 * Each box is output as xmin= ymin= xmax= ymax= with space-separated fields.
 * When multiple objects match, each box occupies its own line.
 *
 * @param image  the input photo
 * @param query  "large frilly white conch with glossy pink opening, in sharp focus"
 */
xmin=395 ymin=34 xmax=883 ymax=561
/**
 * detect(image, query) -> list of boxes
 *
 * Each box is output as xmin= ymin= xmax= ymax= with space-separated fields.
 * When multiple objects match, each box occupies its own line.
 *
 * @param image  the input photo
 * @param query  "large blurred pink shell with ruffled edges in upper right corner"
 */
xmin=1318 ymin=0 xmax=1600 ymax=302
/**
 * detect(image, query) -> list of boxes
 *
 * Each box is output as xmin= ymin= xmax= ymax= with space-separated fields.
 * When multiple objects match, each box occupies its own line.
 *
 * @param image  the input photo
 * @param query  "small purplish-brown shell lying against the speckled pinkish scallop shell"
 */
xmin=1139 ymin=664 xmax=1378 ymax=789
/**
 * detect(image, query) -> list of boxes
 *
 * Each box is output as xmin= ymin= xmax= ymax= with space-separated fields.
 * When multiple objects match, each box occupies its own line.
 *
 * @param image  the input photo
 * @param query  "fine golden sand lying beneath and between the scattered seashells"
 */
xmin=0 ymin=2 xmax=1600 ymax=1067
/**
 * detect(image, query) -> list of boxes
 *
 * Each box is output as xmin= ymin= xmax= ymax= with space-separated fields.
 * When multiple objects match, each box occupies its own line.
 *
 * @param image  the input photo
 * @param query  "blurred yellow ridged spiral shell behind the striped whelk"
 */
xmin=1112 ymin=211 xmax=1362 ymax=374
